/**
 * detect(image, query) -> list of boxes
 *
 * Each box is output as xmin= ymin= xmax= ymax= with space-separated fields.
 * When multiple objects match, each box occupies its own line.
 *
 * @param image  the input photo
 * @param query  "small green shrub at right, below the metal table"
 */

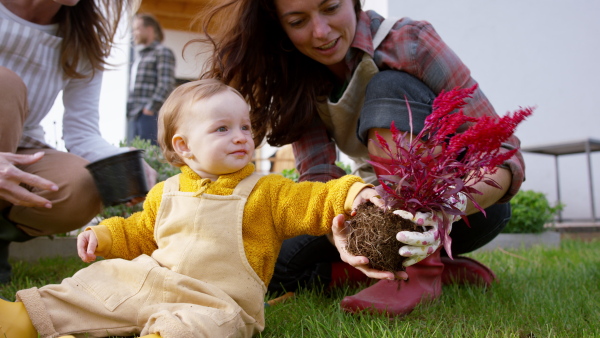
xmin=502 ymin=190 xmax=563 ymax=233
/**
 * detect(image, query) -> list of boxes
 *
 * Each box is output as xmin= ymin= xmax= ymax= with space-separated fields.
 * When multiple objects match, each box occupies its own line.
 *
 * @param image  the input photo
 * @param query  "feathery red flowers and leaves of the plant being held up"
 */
xmin=368 ymin=85 xmax=533 ymax=257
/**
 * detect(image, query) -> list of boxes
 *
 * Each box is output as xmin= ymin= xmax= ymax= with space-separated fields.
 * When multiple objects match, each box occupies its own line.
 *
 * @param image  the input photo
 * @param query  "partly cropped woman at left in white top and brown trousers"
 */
xmin=0 ymin=0 xmax=157 ymax=283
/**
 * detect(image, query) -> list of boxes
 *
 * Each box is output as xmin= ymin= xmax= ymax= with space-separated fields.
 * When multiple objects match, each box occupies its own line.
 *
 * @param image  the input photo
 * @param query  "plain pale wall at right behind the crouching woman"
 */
xmin=365 ymin=0 xmax=600 ymax=218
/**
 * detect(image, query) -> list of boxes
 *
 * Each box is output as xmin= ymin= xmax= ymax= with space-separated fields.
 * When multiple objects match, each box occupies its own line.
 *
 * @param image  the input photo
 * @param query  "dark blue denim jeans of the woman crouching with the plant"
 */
xmin=268 ymin=70 xmax=511 ymax=294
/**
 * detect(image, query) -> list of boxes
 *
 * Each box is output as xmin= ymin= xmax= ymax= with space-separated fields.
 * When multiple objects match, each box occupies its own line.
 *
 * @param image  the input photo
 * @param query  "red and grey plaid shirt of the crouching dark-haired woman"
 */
xmin=293 ymin=11 xmax=525 ymax=203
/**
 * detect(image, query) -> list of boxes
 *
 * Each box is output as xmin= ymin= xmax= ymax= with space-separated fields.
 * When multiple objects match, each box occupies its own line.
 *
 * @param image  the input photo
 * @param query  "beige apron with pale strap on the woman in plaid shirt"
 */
xmin=318 ymin=18 xmax=396 ymax=184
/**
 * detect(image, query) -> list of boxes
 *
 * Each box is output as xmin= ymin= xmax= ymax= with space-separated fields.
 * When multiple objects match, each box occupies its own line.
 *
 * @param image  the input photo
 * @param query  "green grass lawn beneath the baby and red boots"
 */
xmin=0 ymin=240 xmax=600 ymax=338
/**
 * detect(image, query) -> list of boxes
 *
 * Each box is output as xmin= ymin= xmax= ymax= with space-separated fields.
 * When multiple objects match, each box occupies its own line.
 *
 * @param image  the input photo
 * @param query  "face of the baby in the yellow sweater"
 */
xmin=174 ymin=90 xmax=254 ymax=181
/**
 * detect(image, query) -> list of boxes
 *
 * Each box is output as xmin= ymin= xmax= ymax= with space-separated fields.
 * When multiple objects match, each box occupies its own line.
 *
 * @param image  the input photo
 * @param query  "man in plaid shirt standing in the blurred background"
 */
xmin=127 ymin=14 xmax=175 ymax=145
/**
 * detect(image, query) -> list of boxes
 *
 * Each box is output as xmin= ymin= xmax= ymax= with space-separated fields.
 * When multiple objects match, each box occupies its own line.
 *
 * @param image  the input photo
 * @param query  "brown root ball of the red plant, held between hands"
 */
xmin=346 ymin=202 xmax=423 ymax=272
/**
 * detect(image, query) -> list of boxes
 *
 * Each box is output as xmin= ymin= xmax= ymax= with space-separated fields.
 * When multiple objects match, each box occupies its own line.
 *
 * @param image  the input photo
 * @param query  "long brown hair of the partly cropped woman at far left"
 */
xmin=55 ymin=0 xmax=140 ymax=78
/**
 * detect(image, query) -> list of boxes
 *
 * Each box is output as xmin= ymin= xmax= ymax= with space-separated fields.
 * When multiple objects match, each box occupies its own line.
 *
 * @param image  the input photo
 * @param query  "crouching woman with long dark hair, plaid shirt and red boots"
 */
xmin=195 ymin=0 xmax=524 ymax=315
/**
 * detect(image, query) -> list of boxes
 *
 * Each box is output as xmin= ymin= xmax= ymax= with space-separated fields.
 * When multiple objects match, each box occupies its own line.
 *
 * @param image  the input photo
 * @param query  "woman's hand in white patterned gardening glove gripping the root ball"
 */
xmin=394 ymin=193 xmax=467 ymax=266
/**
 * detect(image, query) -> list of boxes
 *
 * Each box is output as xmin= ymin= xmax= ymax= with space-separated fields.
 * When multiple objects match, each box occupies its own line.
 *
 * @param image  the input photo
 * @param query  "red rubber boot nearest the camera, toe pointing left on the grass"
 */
xmin=340 ymin=249 xmax=444 ymax=317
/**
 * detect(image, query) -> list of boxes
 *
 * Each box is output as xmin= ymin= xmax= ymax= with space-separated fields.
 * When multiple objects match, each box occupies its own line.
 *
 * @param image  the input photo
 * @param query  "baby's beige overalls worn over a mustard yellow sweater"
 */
xmin=17 ymin=174 xmax=266 ymax=338
